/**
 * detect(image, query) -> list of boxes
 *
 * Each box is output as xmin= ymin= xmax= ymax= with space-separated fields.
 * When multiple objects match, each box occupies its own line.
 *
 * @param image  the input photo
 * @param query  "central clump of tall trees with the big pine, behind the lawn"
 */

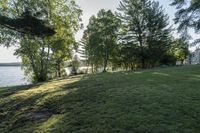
xmin=83 ymin=0 xmax=187 ymax=71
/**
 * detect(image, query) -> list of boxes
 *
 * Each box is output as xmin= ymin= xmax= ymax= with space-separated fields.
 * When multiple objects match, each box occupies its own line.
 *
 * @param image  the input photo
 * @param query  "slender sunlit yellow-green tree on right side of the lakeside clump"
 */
xmin=49 ymin=0 xmax=82 ymax=77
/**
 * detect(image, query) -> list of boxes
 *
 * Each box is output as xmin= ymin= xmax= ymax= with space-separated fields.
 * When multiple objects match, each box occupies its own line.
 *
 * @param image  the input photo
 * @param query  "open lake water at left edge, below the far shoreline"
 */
xmin=0 ymin=66 xmax=29 ymax=87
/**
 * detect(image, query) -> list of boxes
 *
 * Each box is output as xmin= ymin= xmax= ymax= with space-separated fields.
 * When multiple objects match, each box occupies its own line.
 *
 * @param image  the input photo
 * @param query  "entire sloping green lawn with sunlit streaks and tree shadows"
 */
xmin=0 ymin=66 xmax=200 ymax=133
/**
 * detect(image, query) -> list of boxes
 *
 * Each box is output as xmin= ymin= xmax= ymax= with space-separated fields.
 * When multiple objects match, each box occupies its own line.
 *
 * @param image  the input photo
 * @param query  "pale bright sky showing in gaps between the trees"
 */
xmin=0 ymin=0 xmax=188 ymax=63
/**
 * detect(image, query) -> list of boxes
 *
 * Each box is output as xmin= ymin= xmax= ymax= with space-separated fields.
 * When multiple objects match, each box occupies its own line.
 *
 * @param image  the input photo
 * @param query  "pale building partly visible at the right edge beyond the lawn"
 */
xmin=189 ymin=48 xmax=200 ymax=65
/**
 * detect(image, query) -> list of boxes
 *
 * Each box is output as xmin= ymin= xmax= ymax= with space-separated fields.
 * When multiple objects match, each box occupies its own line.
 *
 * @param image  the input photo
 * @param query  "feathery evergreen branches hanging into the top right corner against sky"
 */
xmin=171 ymin=0 xmax=200 ymax=44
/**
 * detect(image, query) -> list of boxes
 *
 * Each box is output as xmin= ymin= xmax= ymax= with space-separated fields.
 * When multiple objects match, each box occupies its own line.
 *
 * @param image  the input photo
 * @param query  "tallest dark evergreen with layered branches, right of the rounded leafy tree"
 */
xmin=118 ymin=0 xmax=171 ymax=69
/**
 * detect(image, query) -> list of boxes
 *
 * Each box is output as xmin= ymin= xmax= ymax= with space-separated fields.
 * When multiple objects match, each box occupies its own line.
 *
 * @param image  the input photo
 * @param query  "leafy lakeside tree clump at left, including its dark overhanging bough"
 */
xmin=0 ymin=0 xmax=82 ymax=82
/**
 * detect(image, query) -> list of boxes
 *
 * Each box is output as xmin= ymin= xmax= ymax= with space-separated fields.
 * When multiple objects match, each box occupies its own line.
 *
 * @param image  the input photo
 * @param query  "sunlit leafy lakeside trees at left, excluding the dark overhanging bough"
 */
xmin=2 ymin=0 xmax=81 ymax=82
